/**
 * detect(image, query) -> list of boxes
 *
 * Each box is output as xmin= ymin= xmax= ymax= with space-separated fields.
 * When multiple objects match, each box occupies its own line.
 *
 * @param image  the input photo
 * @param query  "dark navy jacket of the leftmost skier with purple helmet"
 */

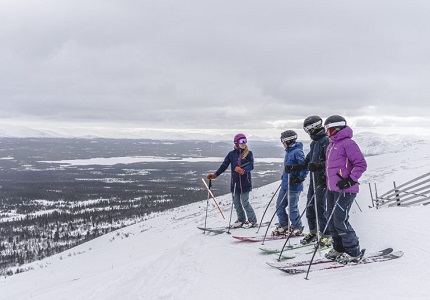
xmin=215 ymin=149 xmax=254 ymax=193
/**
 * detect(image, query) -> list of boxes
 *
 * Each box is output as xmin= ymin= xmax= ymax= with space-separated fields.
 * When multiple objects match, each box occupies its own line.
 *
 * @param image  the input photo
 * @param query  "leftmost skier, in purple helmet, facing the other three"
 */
xmin=207 ymin=133 xmax=257 ymax=228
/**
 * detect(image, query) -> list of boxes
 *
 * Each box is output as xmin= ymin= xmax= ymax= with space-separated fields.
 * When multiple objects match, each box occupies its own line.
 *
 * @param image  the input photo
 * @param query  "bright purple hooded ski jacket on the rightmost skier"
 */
xmin=326 ymin=126 xmax=367 ymax=193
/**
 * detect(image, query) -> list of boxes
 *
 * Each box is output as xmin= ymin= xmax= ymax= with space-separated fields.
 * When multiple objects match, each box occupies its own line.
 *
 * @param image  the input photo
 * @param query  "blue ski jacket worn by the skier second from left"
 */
xmin=282 ymin=142 xmax=308 ymax=192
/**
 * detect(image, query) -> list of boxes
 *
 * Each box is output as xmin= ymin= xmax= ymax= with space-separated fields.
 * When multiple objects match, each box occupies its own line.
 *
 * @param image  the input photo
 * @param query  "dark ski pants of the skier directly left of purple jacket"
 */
xmin=306 ymin=182 xmax=330 ymax=237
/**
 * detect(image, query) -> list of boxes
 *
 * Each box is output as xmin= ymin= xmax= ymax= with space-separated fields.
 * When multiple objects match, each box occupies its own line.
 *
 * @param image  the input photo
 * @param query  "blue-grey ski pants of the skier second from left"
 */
xmin=276 ymin=188 xmax=302 ymax=228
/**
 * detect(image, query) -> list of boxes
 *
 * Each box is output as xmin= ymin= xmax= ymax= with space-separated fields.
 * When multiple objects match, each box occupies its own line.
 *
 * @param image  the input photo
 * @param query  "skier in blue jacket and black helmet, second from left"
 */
xmin=273 ymin=130 xmax=308 ymax=235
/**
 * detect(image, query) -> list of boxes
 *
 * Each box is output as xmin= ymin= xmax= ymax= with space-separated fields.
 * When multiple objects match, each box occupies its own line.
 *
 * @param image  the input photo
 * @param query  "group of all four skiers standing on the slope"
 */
xmin=207 ymin=115 xmax=367 ymax=263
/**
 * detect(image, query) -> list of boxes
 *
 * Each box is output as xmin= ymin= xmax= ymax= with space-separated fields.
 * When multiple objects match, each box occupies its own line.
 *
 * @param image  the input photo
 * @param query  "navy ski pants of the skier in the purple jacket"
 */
xmin=327 ymin=191 xmax=360 ymax=256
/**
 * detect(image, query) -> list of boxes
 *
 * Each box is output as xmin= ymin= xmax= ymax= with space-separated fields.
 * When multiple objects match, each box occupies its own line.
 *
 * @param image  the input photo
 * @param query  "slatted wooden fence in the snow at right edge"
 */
xmin=369 ymin=172 xmax=430 ymax=209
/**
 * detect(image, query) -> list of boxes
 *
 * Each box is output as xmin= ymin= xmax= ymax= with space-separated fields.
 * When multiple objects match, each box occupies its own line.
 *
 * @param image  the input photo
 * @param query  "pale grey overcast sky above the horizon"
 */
xmin=0 ymin=0 xmax=430 ymax=138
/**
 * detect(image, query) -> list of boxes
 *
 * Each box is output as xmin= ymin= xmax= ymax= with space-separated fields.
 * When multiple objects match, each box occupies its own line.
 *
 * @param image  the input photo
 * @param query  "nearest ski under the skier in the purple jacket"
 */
xmin=279 ymin=251 xmax=403 ymax=275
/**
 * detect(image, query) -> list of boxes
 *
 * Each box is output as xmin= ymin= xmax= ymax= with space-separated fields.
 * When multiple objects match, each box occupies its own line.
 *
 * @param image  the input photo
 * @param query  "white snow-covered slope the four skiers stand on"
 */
xmin=0 ymin=137 xmax=430 ymax=300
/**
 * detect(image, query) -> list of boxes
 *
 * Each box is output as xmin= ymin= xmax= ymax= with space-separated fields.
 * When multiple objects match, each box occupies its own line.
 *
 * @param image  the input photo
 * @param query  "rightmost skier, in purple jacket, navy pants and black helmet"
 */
xmin=324 ymin=115 xmax=367 ymax=264
